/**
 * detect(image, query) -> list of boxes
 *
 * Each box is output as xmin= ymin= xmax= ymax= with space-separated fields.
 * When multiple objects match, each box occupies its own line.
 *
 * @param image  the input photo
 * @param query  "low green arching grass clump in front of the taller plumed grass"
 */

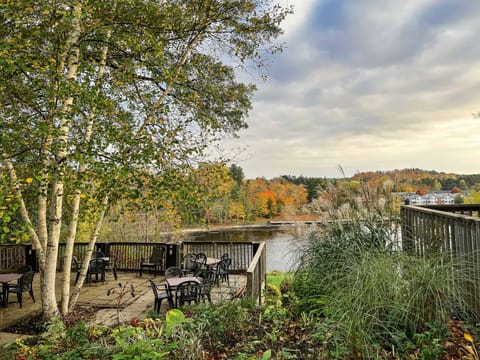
xmin=326 ymin=251 xmax=473 ymax=356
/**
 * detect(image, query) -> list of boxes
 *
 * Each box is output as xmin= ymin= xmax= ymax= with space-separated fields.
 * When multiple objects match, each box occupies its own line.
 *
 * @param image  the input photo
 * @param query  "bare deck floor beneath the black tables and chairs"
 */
xmin=0 ymin=272 xmax=247 ymax=345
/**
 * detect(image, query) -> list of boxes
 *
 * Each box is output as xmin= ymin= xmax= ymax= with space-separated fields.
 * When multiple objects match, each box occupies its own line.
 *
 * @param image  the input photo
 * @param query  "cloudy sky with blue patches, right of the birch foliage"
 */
xmin=225 ymin=0 xmax=480 ymax=179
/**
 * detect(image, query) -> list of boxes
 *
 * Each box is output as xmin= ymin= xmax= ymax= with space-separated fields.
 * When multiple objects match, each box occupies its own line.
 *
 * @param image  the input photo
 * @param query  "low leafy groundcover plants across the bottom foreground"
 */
xmin=3 ymin=273 xmax=480 ymax=360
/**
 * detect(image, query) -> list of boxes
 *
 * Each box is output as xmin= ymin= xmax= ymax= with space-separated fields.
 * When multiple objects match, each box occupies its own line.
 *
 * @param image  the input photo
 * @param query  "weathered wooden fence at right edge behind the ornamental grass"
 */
xmin=400 ymin=205 xmax=480 ymax=314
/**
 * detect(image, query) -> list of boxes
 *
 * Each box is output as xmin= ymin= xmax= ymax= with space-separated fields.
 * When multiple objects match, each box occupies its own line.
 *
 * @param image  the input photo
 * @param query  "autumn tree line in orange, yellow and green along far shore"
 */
xmin=0 ymin=166 xmax=480 ymax=243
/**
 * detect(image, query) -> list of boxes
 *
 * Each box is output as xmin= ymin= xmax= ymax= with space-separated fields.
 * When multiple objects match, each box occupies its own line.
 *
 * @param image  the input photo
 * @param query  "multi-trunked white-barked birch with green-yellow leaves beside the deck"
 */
xmin=0 ymin=0 xmax=290 ymax=318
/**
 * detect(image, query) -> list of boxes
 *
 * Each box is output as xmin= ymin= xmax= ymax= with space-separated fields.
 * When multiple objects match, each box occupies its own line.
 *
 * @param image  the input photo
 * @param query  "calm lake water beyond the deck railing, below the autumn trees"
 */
xmin=191 ymin=228 xmax=298 ymax=271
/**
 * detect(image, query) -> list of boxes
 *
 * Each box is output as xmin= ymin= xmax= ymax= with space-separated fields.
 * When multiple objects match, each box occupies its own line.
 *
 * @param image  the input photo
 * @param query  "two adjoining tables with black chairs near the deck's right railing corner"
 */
xmin=149 ymin=253 xmax=232 ymax=312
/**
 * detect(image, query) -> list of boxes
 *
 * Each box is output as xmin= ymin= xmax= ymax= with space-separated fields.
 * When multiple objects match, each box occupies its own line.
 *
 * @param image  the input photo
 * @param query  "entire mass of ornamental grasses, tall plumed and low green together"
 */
xmin=293 ymin=180 xmax=479 ymax=358
